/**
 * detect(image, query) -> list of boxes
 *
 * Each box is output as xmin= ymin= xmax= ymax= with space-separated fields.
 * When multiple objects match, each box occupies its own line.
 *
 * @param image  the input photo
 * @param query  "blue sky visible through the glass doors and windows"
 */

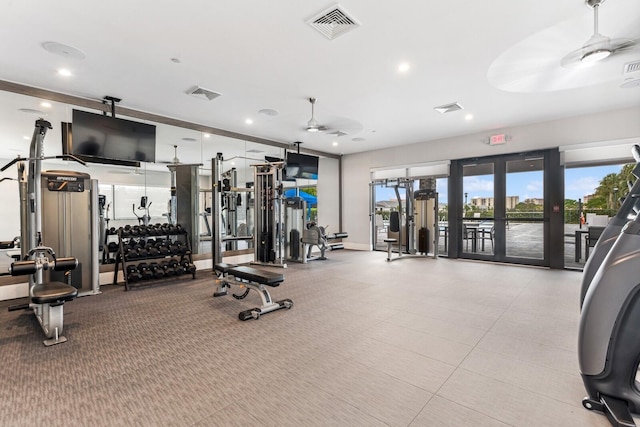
xmin=376 ymin=165 xmax=622 ymax=203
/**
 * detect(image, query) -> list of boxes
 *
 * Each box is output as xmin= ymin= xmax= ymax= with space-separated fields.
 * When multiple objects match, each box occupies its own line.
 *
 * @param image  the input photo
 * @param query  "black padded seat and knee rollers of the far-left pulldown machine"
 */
xmin=9 ymin=251 xmax=78 ymax=346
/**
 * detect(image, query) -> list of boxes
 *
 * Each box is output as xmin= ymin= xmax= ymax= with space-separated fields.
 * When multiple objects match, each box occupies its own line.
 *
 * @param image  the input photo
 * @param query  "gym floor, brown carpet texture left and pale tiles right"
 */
xmin=0 ymin=251 xmax=620 ymax=426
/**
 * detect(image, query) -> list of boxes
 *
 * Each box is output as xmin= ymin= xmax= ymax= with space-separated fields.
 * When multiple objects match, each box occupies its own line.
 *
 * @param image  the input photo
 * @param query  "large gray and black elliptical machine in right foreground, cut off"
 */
xmin=578 ymin=146 xmax=640 ymax=427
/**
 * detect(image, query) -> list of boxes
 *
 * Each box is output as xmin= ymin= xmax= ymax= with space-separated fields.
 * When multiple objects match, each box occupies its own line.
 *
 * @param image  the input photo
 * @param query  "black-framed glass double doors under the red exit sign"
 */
xmin=457 ymin=153 xmax=548 ymax=265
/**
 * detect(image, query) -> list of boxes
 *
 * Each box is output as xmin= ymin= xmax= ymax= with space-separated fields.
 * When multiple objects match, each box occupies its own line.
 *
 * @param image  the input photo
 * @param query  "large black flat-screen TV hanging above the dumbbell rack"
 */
xmin=62 ymin=110 xmax=156 ymax=166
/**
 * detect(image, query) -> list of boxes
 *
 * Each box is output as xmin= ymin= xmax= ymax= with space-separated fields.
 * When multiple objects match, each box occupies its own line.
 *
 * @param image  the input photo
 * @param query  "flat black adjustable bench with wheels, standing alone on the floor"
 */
xmin=213 ymin=263 xmax=293 ymax=320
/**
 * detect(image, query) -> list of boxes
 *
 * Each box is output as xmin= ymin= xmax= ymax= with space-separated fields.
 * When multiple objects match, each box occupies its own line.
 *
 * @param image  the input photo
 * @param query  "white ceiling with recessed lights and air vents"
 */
xmin=0 ymin=0 xmax=640 ymax=165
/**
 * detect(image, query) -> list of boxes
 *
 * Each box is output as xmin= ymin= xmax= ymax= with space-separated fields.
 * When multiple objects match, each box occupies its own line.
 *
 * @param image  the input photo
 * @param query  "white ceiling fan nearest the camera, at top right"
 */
xmin=560 ymin=0 xmax=636 ymax=68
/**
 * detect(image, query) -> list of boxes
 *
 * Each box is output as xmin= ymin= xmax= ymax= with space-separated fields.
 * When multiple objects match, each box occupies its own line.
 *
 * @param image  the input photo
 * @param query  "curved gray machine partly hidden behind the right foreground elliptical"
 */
xmin=580 ymin=145 xmax=640 ymax=307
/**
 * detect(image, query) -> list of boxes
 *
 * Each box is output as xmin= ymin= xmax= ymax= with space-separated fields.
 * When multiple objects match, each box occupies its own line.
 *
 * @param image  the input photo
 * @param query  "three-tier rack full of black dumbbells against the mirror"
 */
xmin=113 ymin=224 xmax=196 ymax=291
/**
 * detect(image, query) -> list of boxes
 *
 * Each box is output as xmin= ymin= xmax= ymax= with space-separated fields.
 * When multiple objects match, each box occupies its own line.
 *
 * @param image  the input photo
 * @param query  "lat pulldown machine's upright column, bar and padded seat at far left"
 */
xmin=1 ymin=119 xmax=85 ymax=346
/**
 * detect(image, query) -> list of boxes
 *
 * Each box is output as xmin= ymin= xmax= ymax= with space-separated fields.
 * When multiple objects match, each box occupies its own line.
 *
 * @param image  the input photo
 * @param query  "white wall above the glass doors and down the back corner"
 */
xmin=342 ymin=108 xmax=640 ymax=250
